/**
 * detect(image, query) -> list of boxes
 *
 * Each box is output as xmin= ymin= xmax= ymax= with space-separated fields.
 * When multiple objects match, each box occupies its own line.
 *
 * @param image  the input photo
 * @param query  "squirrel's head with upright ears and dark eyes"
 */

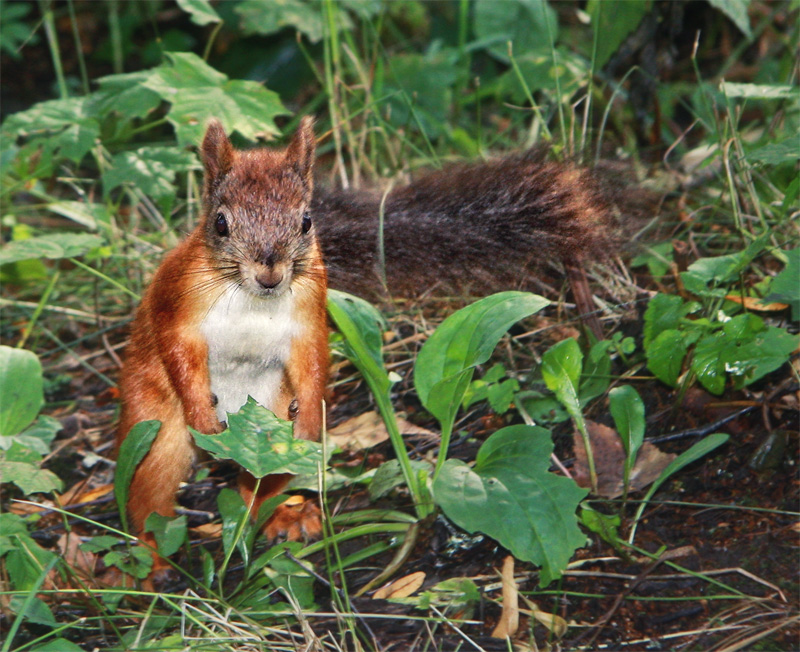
xmin=201 ymin=117 xmax=319 ymax=296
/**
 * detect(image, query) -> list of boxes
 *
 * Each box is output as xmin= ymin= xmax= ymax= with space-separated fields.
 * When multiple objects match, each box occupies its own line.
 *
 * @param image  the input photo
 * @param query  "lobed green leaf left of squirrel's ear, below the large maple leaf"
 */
xmin=103 ymin=147 xmax=200 ymax=215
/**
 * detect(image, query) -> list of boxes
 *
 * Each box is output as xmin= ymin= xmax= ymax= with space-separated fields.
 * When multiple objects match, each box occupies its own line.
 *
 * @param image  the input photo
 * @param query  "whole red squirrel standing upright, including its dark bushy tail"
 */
xmin=117 ymin=118 xmax=636 ymax=552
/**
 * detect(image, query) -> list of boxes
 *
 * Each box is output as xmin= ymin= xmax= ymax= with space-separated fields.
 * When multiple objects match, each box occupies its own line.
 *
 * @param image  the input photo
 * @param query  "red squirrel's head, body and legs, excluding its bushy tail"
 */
xmin=117 ymin=118 xmax=329 ymax=544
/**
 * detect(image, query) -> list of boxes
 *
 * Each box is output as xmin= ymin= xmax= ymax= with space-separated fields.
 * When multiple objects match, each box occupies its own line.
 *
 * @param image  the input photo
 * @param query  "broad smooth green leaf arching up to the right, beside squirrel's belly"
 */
xmin=414 ymin=292 xmax=549 ymax=436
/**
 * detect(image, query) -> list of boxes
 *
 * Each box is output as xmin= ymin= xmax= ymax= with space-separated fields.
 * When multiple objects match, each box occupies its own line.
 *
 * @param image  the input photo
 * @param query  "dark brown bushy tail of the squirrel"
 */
xmin=313 ymin=154 xmax=644 ymax=314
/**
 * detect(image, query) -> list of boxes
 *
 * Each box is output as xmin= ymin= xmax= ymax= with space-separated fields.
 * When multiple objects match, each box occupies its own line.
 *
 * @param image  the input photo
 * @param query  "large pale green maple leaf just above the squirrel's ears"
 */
xmin=143 ymin=52 xmax=288 ymax=145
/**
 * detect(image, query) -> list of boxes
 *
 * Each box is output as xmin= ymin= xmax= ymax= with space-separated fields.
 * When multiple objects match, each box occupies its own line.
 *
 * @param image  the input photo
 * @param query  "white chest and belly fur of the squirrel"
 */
xmin=201 ymin=286 xmax=301 ymax=421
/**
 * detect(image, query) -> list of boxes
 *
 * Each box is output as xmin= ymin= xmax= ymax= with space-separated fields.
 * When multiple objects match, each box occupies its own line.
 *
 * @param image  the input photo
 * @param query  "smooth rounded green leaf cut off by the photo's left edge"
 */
xmin=0 ymin=345 xmax=44 ymax=436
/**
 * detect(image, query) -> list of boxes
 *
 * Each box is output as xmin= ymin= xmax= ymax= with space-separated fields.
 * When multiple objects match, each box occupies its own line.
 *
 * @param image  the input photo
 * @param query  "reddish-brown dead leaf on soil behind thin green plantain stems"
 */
xmin=573 ymin=421 xmax=676 ymax=498
